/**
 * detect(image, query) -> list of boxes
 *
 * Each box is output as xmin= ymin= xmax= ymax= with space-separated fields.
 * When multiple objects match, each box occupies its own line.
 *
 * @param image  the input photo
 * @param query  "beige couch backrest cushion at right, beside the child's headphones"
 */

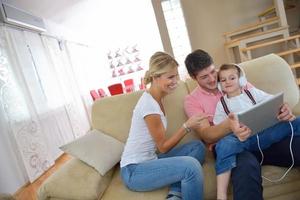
xmin=240 ymin=54 xmax=299 ymax=107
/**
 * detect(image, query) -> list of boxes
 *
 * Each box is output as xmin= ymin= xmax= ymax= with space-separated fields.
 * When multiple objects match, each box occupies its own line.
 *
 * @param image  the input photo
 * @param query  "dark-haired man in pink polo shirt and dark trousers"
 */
xmin=184 ymin=50 xmax=300 ymax=200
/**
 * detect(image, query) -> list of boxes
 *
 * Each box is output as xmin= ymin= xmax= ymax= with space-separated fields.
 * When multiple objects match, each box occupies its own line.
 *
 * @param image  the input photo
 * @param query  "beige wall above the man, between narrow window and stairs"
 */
xmin=181 ymin=0 xmax=273 ymax=65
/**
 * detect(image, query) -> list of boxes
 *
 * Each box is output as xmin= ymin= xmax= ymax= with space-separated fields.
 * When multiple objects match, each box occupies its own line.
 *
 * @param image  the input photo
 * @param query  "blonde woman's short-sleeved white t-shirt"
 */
xmin=120 ymin=92 xmax=167 ymax=167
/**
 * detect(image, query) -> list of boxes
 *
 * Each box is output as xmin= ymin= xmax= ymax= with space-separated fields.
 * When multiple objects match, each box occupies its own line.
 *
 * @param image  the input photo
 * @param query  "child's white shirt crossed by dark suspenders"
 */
xmin=213 ymin=87 xmax=272 ymax=125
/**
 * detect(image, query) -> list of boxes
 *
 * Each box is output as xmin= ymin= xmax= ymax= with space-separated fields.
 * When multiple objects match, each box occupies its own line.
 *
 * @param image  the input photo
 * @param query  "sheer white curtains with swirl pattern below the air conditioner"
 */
xmin=0 ymin=26 xmax=90 ymax=182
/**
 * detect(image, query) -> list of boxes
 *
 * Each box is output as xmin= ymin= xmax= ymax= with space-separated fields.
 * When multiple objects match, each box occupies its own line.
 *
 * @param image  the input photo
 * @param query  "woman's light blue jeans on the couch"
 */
xmin=121 ymin=141 xmax=205 ymax=200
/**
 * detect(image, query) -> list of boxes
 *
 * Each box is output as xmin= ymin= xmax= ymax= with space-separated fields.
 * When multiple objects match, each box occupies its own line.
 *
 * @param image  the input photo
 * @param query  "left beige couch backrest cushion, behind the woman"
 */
xmin=92 ymin=81 xmax=195 ymax=142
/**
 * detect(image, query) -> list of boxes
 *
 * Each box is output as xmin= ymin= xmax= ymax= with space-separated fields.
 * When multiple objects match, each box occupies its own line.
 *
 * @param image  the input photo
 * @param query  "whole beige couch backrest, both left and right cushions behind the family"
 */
xmin=92 ymin=54 xmax=299 ymax=143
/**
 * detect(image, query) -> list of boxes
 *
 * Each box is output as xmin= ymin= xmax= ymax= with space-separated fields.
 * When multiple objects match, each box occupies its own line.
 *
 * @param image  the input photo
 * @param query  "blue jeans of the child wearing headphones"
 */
xmin=215 ymin=117 xmax=300 ymax=175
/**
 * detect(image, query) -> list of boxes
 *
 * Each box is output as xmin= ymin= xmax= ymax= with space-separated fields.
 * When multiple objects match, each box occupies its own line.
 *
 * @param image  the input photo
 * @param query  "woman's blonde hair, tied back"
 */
xmin=144 ymin=52 xmax=178 ymax=85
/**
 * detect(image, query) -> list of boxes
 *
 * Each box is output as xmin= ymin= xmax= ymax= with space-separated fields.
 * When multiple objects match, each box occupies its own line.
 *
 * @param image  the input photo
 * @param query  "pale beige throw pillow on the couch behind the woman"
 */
xmin=60 ymin=129 xmax=124 ymax=176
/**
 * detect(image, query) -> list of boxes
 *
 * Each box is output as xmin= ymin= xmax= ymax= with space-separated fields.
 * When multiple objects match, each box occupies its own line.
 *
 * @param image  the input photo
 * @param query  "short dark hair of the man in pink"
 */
xmin=184 ymin=49 xmax=214 ymax=77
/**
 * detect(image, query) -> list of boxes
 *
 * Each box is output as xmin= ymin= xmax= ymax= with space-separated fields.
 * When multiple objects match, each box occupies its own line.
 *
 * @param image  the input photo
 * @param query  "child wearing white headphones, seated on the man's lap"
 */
xmin=213 ymin=64 xmax=300 ymax=200
